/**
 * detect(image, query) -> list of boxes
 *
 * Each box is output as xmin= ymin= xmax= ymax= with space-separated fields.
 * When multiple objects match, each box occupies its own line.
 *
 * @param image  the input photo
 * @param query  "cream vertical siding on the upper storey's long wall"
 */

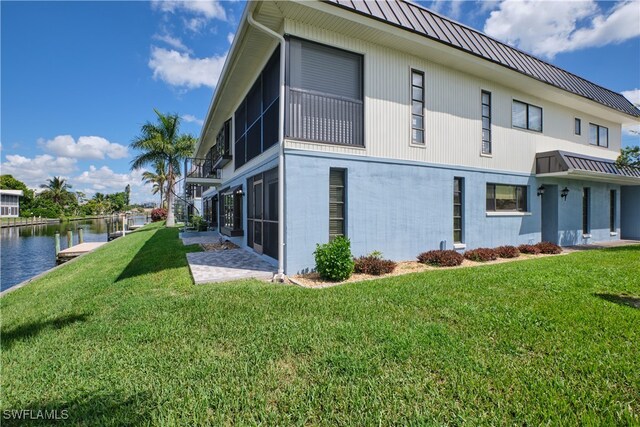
xmin=285 ymin=16 xmax=621 ymax=172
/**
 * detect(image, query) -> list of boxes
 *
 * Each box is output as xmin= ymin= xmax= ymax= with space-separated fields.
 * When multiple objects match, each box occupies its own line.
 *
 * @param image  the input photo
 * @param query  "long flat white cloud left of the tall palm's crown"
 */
xmin=38 ymin=135 xmax=129 ymax=159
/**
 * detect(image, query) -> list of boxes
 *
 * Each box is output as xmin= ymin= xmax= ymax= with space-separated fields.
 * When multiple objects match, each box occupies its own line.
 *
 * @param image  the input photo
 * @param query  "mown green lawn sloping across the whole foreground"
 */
xmin=0 ymin=225 xmax=640 ymax=426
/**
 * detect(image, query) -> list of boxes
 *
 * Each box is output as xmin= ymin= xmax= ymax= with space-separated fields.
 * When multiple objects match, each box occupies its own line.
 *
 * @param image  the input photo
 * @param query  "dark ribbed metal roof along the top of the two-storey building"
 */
xmin=324 ymin=0 xmax=640 ymax=117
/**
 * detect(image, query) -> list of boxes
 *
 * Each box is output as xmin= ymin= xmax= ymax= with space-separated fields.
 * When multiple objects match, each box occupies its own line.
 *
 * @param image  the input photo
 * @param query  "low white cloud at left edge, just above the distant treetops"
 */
xmin=1 ymin=154 xmax=77 ymax=188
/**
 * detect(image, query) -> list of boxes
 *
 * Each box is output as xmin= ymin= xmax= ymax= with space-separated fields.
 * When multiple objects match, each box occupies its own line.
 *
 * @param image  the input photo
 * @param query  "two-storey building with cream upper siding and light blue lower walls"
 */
xmin=185 ymin=0 xmax=640 ymax=274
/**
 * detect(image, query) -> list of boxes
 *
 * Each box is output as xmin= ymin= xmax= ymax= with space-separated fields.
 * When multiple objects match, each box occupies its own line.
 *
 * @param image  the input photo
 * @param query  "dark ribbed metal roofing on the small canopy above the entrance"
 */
xmin=536 ymin=150 xmax=640 ymax=178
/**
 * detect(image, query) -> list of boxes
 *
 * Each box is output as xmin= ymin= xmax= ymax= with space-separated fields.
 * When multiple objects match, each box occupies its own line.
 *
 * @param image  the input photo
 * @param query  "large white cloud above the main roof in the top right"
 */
xmin=484 ymin=0 xmax=640 ymax=58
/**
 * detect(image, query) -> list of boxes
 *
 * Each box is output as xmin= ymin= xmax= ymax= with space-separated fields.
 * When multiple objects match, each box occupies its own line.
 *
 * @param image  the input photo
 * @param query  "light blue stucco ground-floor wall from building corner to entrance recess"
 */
xmin=285 ymin=150 xmax=540 ymax=274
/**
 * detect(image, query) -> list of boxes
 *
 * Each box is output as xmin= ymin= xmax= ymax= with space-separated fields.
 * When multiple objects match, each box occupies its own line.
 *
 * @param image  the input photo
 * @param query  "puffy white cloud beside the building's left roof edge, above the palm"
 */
xmin=149 ymin=46 xmax=227 ymax=89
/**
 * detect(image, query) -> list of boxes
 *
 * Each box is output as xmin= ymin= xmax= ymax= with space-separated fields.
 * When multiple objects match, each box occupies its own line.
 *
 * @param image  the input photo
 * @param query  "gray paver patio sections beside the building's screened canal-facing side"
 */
xmin=180 ymin=231 xmax=277 ymax=285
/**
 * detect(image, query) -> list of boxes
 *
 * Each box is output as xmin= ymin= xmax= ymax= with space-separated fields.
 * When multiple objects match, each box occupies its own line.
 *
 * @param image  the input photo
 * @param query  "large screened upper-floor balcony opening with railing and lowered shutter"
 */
xmin=286 ymin=37 xmax=364 ymax=146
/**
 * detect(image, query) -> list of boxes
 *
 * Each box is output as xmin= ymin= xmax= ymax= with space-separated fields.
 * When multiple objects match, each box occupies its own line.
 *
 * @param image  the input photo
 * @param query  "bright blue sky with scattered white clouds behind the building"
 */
xmin=0 ymin=0 xmax=640 ymax=206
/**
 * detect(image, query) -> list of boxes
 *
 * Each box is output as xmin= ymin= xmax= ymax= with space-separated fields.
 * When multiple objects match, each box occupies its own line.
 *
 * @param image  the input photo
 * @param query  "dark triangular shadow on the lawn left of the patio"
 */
xmin=116 ymin=228 xmax=199 ymax=282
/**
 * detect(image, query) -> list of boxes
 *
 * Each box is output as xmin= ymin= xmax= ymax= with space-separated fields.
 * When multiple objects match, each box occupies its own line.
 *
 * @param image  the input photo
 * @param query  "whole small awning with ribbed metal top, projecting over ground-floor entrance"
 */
xmin=536 ymin=150 xmax=640 ymax=185
